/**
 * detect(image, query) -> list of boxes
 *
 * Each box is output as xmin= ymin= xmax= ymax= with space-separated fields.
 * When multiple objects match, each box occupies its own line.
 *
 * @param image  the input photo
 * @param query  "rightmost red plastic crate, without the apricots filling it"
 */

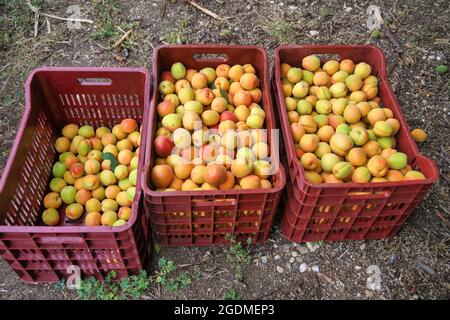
xmin=272 ymin=45 xmax=439 ymax=242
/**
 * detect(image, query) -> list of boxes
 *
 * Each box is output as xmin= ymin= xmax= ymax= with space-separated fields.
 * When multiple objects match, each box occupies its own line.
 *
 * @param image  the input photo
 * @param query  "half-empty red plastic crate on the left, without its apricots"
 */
xmin=0 ymin=68 xmax=150 ymax=282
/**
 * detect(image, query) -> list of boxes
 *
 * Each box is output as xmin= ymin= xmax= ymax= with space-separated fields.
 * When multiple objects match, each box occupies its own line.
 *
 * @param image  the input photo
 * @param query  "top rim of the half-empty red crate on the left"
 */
xmin=0 ymin=66 xmax=151 ymax=234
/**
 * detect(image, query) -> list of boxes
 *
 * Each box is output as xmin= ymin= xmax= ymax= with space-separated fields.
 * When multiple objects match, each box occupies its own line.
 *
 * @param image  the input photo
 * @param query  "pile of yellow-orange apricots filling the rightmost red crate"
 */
xmin=280 ymin=55 xmax=425 ymax=184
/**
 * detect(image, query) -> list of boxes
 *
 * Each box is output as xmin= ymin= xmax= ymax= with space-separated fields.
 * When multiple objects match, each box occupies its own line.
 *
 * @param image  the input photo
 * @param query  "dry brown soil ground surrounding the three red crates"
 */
xmin=0 ymin=0 xmax=450 ymax=299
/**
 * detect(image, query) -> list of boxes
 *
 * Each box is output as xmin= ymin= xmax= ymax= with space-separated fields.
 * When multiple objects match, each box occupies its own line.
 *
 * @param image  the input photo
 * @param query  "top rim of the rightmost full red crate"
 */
xmin=271 ymin=44 xmax=439 ymax=190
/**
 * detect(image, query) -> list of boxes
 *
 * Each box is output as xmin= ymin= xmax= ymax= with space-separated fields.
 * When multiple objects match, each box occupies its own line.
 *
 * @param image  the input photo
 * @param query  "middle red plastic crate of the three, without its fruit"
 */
xmin=142 ymin=45 xmax=285 ymax=246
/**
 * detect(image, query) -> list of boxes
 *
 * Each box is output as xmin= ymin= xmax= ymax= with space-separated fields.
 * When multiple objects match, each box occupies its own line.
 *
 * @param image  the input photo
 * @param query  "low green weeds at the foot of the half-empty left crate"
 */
xmin=77 ymin=271 xmax=152 ymax=300
